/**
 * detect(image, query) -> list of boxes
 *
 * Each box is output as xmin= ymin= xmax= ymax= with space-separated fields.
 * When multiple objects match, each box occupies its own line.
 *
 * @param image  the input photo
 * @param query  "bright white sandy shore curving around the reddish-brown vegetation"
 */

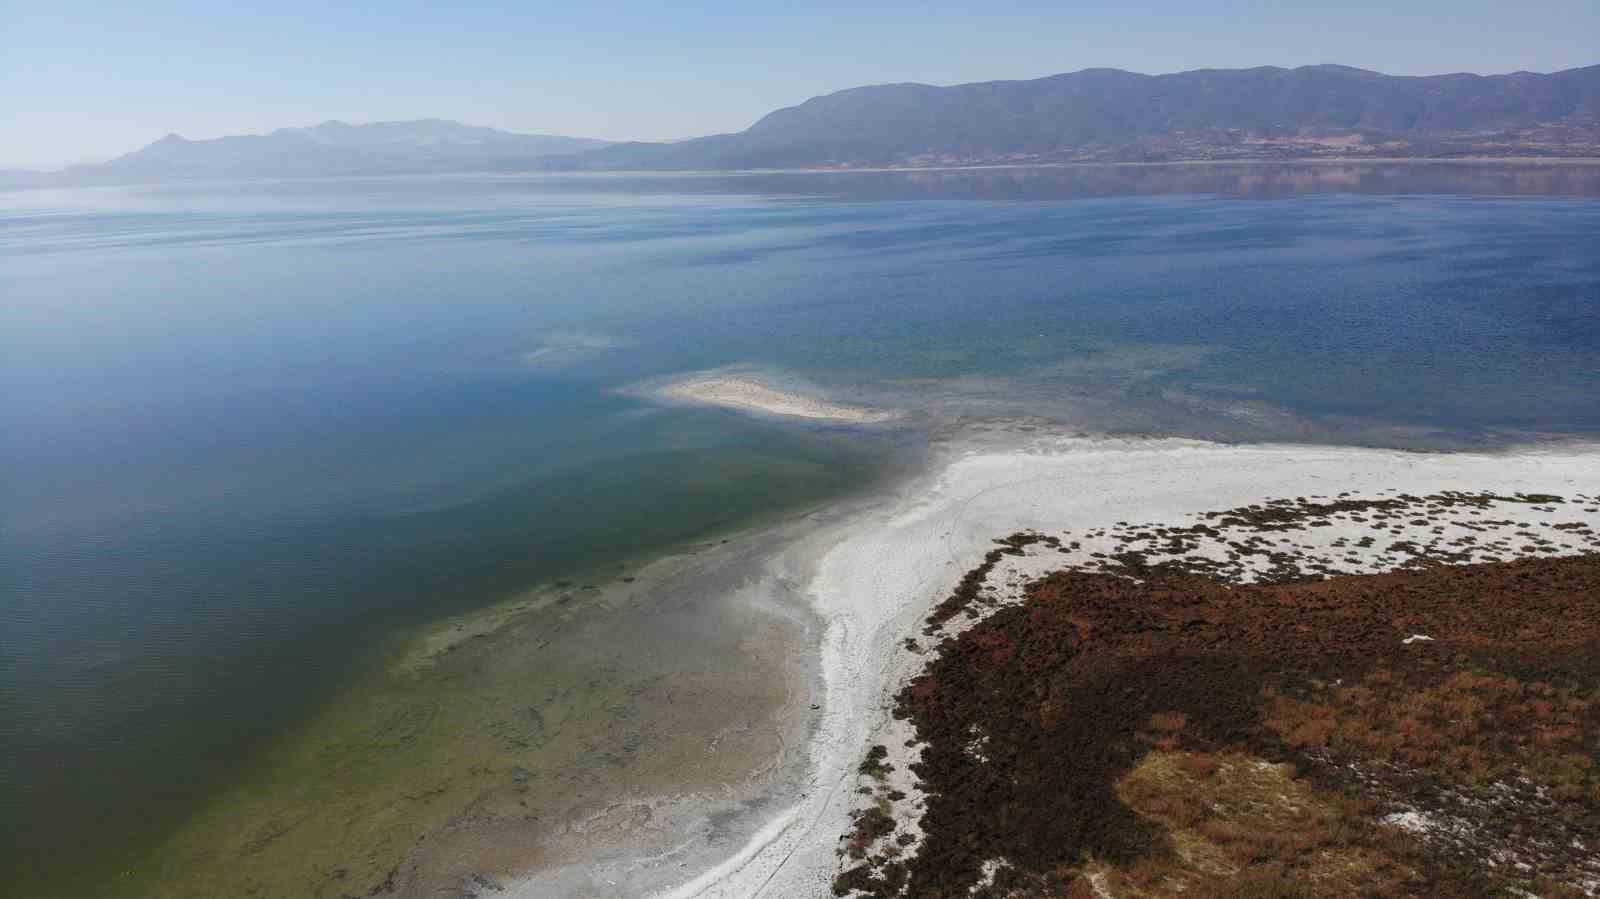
xmin=659 ymin=438 xmax=1600 ymax=899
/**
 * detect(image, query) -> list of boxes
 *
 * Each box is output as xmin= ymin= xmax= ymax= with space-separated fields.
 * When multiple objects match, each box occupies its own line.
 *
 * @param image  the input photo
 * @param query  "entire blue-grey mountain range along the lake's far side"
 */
xmin=12 ymin=66 xmax=1600 ymax=184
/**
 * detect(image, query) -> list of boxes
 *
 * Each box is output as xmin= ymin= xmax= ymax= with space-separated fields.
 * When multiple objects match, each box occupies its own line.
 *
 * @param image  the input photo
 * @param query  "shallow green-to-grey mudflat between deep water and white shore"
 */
xmin=115 ymin=483 xmax=876 ymax=897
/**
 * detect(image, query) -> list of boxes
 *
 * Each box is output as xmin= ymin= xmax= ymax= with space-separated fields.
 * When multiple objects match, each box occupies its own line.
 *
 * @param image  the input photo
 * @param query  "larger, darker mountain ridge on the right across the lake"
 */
xmin=546 ymin=66 xmax=1600 ymax=170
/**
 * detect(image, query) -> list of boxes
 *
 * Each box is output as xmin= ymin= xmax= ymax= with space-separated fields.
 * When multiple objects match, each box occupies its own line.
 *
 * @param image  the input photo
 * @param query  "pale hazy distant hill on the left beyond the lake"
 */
xmin=51 ymin=118 xmax=608 ymax=182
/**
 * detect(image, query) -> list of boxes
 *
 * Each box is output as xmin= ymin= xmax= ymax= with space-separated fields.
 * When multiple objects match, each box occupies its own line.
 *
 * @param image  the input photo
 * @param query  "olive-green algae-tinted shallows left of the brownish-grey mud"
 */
xmin=118 ymin=591 xmax=627 ymax=897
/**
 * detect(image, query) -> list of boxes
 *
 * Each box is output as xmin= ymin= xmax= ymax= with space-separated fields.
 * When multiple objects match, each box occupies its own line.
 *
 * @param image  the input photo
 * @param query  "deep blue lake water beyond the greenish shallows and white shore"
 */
xmin=0 ymin=165 xmax=1600 ymax=877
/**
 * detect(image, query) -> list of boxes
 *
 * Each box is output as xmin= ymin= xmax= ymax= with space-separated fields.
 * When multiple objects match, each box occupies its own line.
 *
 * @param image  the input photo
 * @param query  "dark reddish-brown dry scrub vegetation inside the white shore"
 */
xmin=835 ymin=521 xmax=1600 ymax=897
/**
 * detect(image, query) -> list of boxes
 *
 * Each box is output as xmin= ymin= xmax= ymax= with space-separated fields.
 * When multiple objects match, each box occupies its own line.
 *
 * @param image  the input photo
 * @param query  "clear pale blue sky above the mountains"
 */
xmin=0 ymin=0 xmax=1600 ymax=168
